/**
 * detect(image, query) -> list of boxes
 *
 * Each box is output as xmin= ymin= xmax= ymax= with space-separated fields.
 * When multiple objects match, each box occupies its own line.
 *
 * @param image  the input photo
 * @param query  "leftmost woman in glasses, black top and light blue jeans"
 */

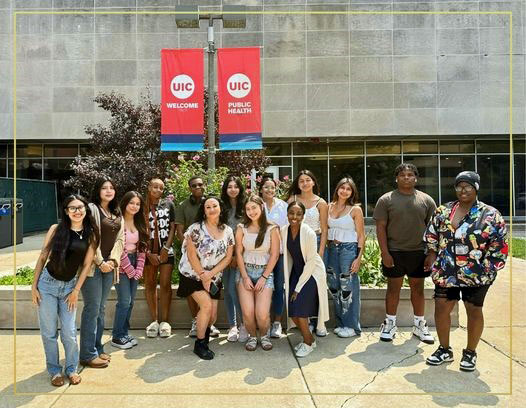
xmin=31 ymin=194 xmax=99 ymax=387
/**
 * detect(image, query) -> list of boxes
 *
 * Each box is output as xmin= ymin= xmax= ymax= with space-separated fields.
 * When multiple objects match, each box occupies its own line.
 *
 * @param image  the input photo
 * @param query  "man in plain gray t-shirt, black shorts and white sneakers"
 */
xmin=373 ymin=164 xmax=436 ymax=344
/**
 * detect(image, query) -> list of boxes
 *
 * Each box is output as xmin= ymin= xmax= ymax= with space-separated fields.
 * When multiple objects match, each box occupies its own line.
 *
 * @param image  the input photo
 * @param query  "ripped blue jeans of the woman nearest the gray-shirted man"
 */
xmin=327 ymin=242 xmax=362 ymax=333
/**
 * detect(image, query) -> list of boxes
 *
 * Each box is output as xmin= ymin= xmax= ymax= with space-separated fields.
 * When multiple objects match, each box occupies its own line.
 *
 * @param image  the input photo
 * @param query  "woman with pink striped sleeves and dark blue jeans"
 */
xmin=111 ymin=191 xmax=148 ymax=350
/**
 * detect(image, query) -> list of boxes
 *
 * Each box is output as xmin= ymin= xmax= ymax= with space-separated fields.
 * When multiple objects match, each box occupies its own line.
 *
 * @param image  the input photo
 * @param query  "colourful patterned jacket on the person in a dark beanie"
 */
xmin=424 ymin=201 xmax=508 ymax=287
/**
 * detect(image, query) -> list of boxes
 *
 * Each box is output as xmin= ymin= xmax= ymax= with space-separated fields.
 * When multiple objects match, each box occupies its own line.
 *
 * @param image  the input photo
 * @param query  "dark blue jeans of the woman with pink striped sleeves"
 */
xmin=112 ymin=254 xmax=139 ymax=339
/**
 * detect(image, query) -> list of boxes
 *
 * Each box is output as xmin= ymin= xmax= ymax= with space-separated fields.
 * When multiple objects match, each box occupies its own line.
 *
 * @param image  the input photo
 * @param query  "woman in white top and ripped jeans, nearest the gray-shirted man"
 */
xmin=327 ymin=177 xmax=365 ymax=338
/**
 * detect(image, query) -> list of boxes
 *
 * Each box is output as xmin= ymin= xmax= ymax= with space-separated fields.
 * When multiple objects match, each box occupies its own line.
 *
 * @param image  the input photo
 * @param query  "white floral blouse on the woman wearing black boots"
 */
xmin=179 ymin=222 xmax=235 ymax=284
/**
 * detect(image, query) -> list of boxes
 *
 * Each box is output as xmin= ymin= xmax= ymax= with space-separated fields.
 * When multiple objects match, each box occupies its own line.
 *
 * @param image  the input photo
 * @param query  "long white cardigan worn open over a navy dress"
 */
xmin=281 ymin=222 xmax=329 ymax=330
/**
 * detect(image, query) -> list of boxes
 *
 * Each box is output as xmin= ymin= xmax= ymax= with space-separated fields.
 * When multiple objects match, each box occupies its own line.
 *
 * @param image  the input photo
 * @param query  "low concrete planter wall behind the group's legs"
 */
xmin=0 ymin=286 xmax=458 ymax=329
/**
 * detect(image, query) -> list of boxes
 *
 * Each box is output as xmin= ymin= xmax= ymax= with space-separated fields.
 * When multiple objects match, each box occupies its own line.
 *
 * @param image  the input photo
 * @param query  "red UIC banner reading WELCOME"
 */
xmin=161 ymin=48 xmax=204 ymax=151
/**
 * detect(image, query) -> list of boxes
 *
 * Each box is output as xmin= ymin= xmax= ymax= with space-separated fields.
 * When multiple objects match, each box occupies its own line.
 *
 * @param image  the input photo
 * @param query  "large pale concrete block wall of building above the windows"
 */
xmin=0 ymin=0 xmax=526 ymax=140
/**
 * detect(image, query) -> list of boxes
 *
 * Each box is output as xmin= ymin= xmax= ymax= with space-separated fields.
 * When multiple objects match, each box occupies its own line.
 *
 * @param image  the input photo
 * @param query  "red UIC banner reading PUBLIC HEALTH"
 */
xmin=217 ymin=47 xmax=263 ymax=150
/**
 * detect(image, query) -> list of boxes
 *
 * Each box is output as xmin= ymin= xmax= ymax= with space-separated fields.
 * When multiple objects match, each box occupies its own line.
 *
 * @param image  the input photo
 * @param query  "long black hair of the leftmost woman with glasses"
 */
xmin=47 ymin=194 xmax=100 ymax=272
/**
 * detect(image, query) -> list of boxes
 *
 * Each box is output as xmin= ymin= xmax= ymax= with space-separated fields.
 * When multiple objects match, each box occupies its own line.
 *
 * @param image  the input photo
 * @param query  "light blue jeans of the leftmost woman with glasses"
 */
xmin=37 ymin=268 xmax=79 ymax=377
